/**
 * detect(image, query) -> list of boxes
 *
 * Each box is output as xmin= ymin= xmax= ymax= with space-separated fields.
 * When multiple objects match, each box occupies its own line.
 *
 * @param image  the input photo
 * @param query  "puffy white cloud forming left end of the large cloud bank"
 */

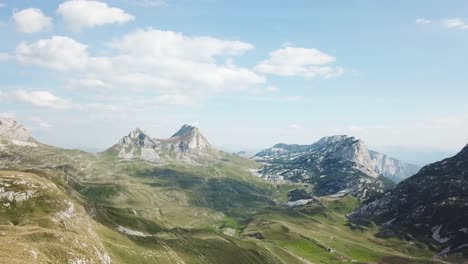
xmin=16 ymin=36 xmax=90 ymax=71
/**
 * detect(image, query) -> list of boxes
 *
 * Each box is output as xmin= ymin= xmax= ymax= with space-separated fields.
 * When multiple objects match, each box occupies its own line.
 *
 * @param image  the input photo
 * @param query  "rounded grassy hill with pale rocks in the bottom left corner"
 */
xmin=0 ymin=171 xmax=107 ymax=264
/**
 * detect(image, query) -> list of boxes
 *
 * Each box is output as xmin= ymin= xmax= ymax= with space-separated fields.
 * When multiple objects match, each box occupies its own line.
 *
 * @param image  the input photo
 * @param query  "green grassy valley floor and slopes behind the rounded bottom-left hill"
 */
xmin=0 ymin=143 xmax=446 ymax=263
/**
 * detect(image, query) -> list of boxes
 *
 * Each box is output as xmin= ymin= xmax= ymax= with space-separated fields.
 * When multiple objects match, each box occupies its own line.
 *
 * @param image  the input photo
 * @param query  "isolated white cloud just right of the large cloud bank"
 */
xmin=255 ymin=47 xmax=344 ymax=78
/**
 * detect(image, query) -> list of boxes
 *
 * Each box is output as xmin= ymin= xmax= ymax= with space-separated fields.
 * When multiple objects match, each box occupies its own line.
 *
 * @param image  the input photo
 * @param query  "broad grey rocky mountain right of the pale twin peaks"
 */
xmin=254 ymin=135 xmax=418 ymax=199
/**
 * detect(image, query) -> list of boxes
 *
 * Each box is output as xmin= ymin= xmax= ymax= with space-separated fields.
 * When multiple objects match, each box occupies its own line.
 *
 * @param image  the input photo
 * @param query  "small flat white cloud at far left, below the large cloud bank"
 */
xmin=14 ymin=90 xmax=72 ymax=109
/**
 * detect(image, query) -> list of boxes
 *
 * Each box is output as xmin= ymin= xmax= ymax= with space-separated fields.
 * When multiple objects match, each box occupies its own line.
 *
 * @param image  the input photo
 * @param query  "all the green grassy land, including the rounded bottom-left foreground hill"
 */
xmin=0 ymin=120 xmax=454 ymax=264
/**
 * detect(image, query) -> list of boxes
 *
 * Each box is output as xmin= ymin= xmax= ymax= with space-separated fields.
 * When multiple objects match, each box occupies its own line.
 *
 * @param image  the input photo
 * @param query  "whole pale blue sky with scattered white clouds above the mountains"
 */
xmin=0 ymin=0 xmax=468 ymax=163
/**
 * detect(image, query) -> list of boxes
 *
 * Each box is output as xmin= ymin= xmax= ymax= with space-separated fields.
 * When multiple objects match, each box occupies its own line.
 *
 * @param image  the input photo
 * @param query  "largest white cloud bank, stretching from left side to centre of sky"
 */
xmin=15 ymin=29 xmax=265 ymax=98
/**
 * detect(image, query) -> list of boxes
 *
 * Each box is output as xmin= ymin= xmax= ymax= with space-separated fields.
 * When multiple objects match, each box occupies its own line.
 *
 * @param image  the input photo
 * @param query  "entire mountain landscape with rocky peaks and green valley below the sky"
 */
xmin=0 ymin=119 xmax=468 ymax=264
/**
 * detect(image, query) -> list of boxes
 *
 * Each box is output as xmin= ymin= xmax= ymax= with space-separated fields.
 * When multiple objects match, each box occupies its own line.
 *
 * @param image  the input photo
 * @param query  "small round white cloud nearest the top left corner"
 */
xmin=12 ymin=8 xmax=52 ymax=33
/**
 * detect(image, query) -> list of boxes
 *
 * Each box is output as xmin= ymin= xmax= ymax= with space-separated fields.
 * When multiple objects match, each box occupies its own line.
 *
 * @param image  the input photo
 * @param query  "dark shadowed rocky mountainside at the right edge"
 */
xmin=349 ymin=145 xmax=468 ymax=254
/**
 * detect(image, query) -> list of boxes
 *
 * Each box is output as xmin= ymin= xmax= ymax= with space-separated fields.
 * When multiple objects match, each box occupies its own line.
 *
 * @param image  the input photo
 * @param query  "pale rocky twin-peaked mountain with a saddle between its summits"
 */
xmin=106 ymin=125 xmax=217 ymax=163
